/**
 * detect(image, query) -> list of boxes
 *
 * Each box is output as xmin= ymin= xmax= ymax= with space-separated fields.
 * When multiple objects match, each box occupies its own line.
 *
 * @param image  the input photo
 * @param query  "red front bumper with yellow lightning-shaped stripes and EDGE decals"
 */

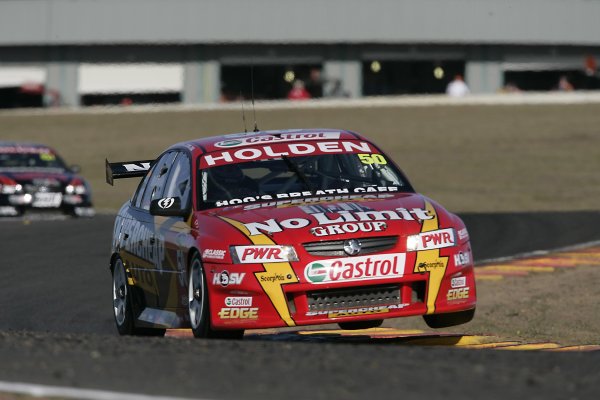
xmin=205 ymin=246 xmax=476 ymax=329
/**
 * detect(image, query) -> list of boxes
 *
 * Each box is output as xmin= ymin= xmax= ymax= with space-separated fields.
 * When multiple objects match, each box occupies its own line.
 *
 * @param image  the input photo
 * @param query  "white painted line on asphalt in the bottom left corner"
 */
xmin=0 ymin=381 xmax=208 ymax=400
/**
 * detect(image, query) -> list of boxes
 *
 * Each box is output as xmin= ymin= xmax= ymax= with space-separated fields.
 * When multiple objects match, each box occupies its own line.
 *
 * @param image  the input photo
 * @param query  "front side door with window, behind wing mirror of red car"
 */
xmin=155 ymin=151 xmax=193 ymax=310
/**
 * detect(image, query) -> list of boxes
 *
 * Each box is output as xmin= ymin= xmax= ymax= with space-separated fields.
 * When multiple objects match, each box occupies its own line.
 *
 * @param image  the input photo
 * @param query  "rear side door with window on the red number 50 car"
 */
xmin=121 ymin=152 xmax=177 ymax=308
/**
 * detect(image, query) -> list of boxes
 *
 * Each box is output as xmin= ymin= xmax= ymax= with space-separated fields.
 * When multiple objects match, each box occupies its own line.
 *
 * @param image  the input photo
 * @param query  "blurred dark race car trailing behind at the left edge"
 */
xmin=0 ymin=141 xmax=95 ymax=217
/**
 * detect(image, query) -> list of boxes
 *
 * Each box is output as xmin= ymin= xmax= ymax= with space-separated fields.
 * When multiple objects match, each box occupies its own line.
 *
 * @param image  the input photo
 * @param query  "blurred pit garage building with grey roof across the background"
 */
xmin=0 ymin=0 xmax=600 ymax=107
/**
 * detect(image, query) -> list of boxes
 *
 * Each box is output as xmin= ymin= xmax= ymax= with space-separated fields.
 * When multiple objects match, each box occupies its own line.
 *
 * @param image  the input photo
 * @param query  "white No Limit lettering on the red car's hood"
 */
xmin=244 ymin=208 xmax=433 ymax=236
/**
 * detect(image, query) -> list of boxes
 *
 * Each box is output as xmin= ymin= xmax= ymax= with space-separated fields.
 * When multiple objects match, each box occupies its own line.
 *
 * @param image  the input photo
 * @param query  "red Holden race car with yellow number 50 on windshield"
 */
xmin=106 ymin=129 xmax=476 ymax=338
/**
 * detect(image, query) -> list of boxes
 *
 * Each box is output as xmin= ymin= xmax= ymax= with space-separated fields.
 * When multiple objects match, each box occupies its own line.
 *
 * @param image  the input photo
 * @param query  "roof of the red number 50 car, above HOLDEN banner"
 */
xmin=170 ymin=129 xmax=366 ymax=153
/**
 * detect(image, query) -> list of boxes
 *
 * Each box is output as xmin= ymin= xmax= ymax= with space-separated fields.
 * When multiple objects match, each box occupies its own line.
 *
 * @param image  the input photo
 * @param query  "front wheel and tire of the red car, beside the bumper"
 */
xmin=188 ymin=253 xmax=244 ymax=339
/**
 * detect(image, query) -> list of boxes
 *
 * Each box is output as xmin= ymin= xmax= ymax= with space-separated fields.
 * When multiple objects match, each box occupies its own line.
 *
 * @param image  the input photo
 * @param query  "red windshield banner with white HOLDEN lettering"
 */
xmin=200 ymin=141 xmax=374 ymax=168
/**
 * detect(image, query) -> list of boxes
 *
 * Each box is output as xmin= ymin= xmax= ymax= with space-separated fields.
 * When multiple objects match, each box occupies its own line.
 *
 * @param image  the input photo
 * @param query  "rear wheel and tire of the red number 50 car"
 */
xmin=112 ymin=257 xmax=166 ymax=336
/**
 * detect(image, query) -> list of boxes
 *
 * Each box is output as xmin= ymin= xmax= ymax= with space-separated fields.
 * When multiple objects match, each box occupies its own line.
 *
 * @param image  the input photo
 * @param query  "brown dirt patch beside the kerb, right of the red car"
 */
xmin=384 ymin=266 xmax=600 ymax=346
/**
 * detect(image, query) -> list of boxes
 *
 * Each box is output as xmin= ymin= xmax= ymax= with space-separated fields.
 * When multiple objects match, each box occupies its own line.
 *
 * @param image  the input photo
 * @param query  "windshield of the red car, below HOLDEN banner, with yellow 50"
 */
xmin=198 ymin=153 xmax=412 ymax=209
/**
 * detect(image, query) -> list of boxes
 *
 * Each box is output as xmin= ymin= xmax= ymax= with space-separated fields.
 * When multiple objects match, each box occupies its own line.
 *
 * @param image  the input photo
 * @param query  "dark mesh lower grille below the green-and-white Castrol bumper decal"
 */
xmin=307 ymin=285 xmax=401 ymax=311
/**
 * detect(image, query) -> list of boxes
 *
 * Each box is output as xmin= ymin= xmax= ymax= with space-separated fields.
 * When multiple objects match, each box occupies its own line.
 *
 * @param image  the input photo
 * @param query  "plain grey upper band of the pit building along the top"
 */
xmin=0 ymin=0 xmax=600 ymax=46
